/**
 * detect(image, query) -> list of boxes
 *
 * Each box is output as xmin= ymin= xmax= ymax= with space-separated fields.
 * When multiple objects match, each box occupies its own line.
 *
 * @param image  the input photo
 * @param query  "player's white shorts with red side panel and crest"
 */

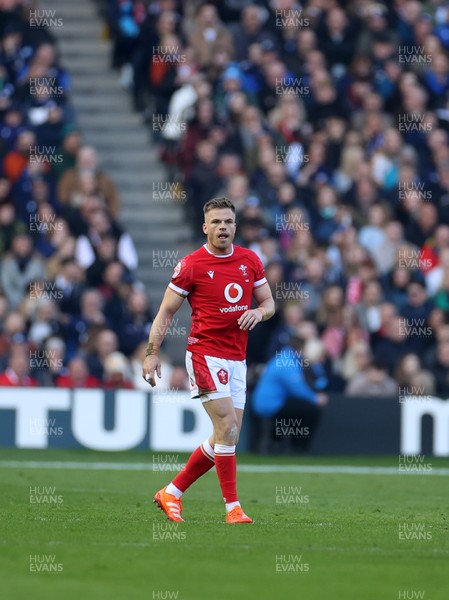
xmin=186 ymin=350 xmax=246 ymax=409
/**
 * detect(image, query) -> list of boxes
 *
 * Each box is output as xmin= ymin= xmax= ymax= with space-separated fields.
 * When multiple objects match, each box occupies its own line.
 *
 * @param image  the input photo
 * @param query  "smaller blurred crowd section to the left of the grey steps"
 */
xmin=0 ymin=0 xmax=178 ymax=389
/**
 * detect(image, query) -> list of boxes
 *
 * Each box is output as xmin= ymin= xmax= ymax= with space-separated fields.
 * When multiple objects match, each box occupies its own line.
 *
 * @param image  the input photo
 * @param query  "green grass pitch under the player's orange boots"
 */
xmin=0 ymin=449 xmax=449 ymax=600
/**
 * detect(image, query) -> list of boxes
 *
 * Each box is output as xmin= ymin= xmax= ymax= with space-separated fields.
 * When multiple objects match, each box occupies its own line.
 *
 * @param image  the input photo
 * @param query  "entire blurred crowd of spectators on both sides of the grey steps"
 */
xmin=0 ymin=0 xmax=449 ymax=397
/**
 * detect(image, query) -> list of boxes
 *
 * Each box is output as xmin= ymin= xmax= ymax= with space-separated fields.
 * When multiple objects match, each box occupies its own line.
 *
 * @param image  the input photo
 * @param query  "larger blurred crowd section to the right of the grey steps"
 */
xmin=107 ymin=0 xmax=449 ymax=397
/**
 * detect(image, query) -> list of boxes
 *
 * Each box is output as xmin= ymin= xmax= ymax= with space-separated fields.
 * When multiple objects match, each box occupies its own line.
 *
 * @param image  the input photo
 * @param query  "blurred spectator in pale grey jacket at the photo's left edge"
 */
xmin=0 ymin=233 xmax=45 ymax=309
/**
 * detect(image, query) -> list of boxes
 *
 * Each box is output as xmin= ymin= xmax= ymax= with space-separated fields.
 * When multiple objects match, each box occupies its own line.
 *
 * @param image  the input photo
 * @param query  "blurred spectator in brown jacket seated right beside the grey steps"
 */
xmin=58 ymin=146 xmax=120 ymax=217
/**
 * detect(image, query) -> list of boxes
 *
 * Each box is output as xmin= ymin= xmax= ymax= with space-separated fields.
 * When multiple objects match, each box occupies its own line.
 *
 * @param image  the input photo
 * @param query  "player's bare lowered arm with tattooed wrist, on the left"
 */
xmin=142 ymin=288 xmax=184 ymax=387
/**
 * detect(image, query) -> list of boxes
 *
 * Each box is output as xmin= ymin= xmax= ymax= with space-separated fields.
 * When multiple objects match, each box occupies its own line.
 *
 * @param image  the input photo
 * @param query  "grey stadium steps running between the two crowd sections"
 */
xmin=39 ymin=0 xmax=193 ymax=363
